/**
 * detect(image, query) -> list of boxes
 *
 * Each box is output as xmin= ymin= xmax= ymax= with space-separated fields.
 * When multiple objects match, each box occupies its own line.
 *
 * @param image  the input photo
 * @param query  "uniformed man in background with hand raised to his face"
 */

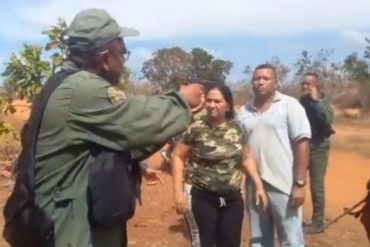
xmin=300 ymin=73 xmax=334 ymax=234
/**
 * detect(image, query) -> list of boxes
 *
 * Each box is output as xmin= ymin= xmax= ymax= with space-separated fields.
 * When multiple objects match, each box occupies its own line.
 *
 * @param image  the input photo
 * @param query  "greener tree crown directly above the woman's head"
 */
xmin=190 ymin=48 xmax=233 ymax=83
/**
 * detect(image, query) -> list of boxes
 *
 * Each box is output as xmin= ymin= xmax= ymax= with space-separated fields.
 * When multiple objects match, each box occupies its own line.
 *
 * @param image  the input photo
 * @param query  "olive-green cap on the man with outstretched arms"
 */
xmin=63 ymin=8 xmax=140 ymax=52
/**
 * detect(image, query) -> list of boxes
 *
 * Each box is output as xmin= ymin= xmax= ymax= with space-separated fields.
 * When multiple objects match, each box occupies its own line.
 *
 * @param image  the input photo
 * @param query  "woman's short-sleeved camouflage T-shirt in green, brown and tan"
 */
xmin=182 ymin=119 xmax=244 ymax=195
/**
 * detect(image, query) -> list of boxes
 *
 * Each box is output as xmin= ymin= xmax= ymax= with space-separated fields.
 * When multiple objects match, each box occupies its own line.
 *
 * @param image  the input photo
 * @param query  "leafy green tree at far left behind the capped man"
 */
xmin=0 ymin=18 xmax=67 ymax=139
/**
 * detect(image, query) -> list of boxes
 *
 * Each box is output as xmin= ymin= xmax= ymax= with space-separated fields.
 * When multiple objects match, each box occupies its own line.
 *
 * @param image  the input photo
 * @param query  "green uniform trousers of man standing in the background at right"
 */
xmin=309 ymin=139 xmax=329 ymax=227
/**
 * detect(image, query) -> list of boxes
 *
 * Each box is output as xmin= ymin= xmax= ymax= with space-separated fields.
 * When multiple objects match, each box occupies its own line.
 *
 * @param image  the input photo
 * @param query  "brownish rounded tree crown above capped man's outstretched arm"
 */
xmin=141 ymin=47 xmax=193 ymax=92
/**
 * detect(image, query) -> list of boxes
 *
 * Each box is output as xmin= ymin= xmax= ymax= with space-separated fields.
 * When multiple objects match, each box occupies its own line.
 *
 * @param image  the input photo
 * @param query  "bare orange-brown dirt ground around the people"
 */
xmin=0 ymin=107 xmax=370 ymax=247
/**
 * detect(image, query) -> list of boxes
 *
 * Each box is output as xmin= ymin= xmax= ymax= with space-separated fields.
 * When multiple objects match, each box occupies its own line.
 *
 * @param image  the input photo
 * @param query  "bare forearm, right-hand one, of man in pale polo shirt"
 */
xmin=294 ymin=138 xmax=310 ymax=179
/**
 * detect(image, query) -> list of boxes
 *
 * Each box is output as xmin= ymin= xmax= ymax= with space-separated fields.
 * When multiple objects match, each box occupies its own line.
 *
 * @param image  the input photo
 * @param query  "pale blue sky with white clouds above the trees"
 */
xmin=0 ymin=0 xmax=370 ymax=81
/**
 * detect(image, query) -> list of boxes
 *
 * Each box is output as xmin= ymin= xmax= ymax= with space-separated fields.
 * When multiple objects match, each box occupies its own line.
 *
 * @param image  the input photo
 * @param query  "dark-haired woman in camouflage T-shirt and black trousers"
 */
xmin=171 ymin=84 xmax=267 ymax=247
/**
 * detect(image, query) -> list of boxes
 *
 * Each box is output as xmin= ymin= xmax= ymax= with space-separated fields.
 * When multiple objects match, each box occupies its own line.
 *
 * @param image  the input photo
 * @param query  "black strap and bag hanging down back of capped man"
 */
xmin=3 ymin=70 xmax=79 ymax=247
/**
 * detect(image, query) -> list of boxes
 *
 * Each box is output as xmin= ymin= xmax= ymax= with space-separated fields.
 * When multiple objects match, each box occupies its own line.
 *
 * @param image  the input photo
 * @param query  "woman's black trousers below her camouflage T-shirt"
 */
xmin=191 ymin=187 xmax=244 ymax=247
